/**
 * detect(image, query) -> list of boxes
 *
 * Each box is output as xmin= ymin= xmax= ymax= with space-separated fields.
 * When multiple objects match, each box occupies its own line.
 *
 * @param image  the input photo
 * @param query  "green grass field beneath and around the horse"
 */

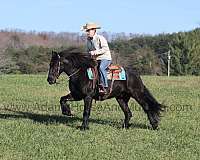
xmin=0 ymin=75 xmax=200 ymax=160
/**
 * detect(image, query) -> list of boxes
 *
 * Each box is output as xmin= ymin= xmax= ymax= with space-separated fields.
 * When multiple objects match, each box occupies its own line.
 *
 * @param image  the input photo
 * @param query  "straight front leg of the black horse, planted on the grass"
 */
xmin=81 ymin=96 xmax=92 ymax=130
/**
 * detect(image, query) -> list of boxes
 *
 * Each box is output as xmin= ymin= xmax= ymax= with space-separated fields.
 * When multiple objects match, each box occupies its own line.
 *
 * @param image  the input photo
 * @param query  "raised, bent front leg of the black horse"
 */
xmin=60 ymin=93 xmax=74 ymax=116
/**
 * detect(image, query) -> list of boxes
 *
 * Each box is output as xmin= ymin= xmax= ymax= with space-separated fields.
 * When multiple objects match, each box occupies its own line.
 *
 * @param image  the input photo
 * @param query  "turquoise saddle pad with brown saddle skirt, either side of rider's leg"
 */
xmin=87 ymin=67 xmax=126 ymax=81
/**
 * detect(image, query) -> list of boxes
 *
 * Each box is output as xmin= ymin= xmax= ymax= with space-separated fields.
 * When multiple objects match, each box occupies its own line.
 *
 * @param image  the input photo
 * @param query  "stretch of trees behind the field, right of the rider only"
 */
xmin=110 ymin=28 xmax=200 ymax=75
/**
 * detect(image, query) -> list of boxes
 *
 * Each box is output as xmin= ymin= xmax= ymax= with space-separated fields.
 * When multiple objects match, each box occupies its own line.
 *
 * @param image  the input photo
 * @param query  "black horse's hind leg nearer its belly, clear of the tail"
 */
xmin=116 ymin=97 xmax=132 ymax=129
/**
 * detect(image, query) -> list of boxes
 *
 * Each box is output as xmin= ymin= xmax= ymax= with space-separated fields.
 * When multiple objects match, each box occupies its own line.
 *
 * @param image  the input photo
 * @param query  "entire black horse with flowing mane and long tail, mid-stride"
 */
xmin=47 ymin=49 xmax=164 ymax=130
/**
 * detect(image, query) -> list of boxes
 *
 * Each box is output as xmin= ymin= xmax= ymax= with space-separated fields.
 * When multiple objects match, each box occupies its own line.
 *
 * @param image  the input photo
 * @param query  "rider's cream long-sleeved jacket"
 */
xmin=87 ymin=34 xmax=112 ymax=60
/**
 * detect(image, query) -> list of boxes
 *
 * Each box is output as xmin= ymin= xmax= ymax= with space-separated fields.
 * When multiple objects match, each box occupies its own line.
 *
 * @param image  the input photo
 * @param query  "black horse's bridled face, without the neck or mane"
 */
xmin=47 ymin=51 xmax=63 ymax=84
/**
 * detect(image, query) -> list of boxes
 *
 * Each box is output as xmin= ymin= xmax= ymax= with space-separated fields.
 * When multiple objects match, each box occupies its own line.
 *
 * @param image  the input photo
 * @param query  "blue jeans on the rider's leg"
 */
xmin=99 ymin=59 xmax=111 ymax=87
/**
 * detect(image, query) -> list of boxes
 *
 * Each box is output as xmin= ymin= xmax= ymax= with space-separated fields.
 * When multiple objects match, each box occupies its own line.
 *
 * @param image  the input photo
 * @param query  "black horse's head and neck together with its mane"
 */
xmin=47 ymin=48 xmax=97 ymax=84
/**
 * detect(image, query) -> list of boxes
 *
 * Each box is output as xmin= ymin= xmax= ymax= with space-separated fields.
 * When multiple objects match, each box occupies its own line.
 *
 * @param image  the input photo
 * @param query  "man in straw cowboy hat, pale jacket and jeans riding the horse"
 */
xmin=82 ymin=23 xmax=112 ymax=94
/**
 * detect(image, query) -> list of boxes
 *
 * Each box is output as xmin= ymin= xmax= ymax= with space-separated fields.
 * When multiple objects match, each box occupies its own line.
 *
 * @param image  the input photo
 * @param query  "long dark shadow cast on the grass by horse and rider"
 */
xmin=0 ymin=110 xmax=149 ymax=129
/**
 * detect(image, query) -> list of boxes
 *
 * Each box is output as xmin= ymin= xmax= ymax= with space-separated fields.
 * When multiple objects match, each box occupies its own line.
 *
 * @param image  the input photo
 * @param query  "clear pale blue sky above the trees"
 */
xmin=0 ymin=0 xmax=200 ymax=34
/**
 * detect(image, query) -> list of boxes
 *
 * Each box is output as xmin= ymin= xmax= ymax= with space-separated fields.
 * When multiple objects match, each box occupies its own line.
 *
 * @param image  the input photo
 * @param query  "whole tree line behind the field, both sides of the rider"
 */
xmin=0 ymin=28 xmax=200 ymax=75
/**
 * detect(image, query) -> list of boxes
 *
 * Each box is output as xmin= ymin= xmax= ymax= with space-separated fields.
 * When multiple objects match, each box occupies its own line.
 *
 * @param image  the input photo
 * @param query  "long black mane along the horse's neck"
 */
xmin=59 ymin=47 xmax=97 ymax=68
